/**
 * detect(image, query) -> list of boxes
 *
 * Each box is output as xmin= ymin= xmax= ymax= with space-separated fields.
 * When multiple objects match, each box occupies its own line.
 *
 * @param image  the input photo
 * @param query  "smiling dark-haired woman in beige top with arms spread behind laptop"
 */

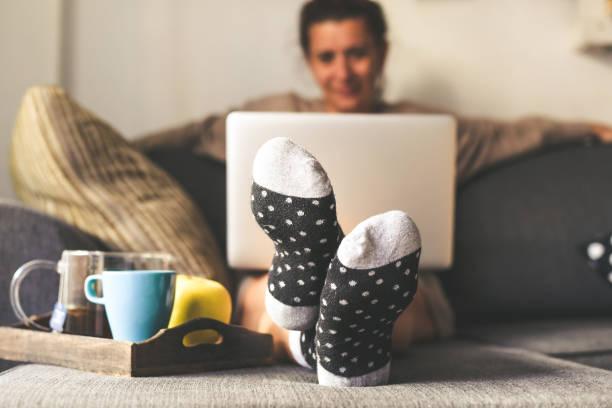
xmin=136 ymin=0 xmax=612 ymax=364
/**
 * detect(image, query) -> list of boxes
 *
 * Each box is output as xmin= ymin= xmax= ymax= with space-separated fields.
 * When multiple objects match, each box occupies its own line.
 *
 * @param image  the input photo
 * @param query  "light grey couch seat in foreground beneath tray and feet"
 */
xmin=0 ymin=341 xmax=612 ymax=408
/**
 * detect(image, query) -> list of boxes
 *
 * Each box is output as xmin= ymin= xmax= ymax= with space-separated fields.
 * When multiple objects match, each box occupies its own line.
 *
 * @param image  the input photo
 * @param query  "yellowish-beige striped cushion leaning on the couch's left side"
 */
xmin=10 ymin=86 xmax=227 ymax=284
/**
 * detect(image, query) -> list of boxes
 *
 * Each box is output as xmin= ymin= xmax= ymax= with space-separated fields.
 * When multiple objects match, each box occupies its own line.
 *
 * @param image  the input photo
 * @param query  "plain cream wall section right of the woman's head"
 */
xmin=382 ymin=0 xmax=612 ymax=123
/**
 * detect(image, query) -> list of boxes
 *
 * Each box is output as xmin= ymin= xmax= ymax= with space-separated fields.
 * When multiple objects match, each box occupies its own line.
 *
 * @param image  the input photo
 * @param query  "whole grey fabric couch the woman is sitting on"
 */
xmin=0 ymin=139 xmax=612 ymax=407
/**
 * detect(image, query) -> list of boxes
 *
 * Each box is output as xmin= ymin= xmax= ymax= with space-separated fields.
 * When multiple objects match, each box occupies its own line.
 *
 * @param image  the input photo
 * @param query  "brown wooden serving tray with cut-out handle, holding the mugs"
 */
xmin=0 ymin=316 xmax=272 ymax=377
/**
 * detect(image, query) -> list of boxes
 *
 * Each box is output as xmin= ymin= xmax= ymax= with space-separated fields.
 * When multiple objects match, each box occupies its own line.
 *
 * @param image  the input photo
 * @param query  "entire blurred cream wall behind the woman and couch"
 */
xmin=0 ymin=0 xmax=612 ymax=198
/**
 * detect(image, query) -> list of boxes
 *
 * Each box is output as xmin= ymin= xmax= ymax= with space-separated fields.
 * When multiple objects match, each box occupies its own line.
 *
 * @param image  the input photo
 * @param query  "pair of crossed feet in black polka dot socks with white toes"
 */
xmin=251 ymin=138 xmax=421 ymax=386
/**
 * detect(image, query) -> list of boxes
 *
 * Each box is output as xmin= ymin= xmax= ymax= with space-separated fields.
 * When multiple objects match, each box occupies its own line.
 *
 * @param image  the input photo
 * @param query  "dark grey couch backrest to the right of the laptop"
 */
xmin=441 ymin=145 xmax=612 ymax=326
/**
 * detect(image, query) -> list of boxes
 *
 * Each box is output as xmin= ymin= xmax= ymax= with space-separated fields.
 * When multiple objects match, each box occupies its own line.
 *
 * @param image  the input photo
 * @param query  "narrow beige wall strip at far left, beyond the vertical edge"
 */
xmin=0 ymin=0 xmax=61 ymax=198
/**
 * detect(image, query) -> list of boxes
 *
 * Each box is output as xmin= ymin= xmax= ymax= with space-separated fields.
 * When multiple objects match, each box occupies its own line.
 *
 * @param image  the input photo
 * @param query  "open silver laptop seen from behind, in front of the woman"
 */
xmin=226 ymin=112 xmax=456 ymax=270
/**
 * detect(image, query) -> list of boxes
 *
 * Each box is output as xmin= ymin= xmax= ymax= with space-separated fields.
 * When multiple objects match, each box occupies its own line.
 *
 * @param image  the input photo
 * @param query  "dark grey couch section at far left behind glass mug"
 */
xmin=0 ymin=200 xmax=112 ymax=371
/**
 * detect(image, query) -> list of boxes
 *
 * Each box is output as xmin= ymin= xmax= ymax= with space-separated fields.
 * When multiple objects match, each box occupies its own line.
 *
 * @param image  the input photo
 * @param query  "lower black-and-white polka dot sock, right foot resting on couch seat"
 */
xmin=315 ymin=211 xmax=421 ymax=386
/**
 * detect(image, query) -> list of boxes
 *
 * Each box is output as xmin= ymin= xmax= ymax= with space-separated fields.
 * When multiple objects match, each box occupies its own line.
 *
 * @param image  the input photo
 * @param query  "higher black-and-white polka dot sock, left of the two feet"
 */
xmin=251 ymin=138 xmax=343 ymax=330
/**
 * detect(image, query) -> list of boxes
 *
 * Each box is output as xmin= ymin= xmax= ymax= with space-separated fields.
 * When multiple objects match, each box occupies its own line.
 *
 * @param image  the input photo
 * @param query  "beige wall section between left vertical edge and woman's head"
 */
xmin=66 ymin=0 xmax=310 ymax=136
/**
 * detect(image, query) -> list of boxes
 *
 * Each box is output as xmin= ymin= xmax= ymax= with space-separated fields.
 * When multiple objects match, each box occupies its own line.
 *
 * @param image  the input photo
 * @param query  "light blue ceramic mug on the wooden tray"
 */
xmin=84 ymin=270 xmax=176 ymax=342
